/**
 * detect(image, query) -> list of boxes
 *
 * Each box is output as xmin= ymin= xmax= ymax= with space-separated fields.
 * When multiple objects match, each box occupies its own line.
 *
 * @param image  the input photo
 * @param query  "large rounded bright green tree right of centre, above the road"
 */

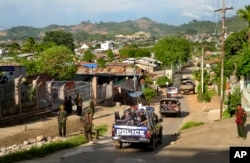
xmin=153 ymin=36 xmax=191 ymax=66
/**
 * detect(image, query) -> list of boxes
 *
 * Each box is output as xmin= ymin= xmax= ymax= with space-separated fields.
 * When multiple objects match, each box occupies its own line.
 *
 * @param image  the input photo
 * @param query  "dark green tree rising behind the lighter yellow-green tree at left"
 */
xmin=43 ymin=30 xmax=74 ymax=52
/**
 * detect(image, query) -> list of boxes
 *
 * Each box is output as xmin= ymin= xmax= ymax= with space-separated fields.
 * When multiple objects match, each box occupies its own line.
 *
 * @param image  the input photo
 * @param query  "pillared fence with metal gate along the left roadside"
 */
xmin=0 ymin=78 xmax=113 ymax=117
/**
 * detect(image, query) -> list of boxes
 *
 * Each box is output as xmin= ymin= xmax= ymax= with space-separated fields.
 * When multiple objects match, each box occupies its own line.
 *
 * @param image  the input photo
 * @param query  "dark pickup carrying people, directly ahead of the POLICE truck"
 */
xmin=159 ymin=98 xmax=181 ymax=116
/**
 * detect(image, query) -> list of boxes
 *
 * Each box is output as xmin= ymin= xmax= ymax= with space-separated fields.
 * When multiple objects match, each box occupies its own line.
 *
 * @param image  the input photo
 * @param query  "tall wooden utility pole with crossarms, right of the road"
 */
xmin=215 ymin=0 xmax=233 ymax=119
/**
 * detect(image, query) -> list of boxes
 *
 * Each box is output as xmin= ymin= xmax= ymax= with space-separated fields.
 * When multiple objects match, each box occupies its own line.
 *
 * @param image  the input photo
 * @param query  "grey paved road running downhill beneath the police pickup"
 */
xmin=19 ymin=95 xmax=191 ymax=163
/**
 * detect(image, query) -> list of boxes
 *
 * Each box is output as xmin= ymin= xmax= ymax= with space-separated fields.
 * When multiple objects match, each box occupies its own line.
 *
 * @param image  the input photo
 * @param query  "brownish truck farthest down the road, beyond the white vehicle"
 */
xmin=179 ymin=78 xmax=195 ymax=94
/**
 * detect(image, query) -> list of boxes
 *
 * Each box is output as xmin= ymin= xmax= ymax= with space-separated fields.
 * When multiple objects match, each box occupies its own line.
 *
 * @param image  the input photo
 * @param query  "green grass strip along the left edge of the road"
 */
xmin=0 ymin=125 xmax=108 ymax=163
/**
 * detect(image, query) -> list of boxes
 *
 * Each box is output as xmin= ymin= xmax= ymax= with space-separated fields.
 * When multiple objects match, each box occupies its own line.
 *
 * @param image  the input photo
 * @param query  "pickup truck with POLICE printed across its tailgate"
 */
xmin=112 ymin=106 xmax=163 ymax=150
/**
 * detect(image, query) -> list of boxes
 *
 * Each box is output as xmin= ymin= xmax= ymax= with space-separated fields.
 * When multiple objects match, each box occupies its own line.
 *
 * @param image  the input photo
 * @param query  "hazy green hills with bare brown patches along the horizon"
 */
xmin=0 ymin=16 xmax=247 ymax=41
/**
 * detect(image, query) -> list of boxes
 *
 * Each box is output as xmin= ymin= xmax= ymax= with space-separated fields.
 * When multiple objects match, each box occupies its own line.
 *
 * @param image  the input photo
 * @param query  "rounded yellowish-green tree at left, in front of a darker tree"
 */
xmin=37 ymin=46 xmax=77 ymax=80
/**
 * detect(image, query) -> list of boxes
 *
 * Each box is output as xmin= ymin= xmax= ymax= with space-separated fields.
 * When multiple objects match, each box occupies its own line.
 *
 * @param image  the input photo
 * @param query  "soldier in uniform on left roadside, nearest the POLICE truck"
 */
xmin=80 ymin=114 xmax=93 ymax=141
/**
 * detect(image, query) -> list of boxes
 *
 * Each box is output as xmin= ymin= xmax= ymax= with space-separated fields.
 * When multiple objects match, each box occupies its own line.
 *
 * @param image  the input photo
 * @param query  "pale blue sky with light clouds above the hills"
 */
xmin=0 ymin=0 xmax=250 ymax=30
